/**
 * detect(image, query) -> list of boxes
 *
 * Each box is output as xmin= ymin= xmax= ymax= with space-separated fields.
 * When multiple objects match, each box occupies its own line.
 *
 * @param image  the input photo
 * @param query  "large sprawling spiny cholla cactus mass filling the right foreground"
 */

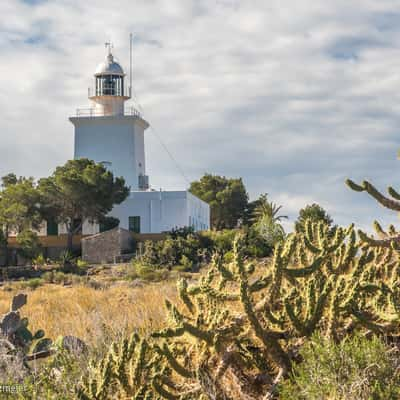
xmin=79 ymin=217 xmax=400 ymax=400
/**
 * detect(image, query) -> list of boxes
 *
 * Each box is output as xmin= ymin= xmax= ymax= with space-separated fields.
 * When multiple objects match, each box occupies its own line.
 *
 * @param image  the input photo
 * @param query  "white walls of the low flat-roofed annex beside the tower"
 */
xmin=110 ymin=191 xmax=210 ymax=233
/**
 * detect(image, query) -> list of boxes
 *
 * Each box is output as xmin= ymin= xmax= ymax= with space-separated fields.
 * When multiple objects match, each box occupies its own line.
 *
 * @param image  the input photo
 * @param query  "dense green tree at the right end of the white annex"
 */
xmin=189 ymin=174 xmax=248 ymax=230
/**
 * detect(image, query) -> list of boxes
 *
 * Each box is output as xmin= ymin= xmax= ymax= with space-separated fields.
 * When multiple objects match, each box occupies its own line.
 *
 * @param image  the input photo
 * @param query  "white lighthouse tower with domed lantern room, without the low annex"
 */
xmin=70 ymin=44 xmax=149 ymax=190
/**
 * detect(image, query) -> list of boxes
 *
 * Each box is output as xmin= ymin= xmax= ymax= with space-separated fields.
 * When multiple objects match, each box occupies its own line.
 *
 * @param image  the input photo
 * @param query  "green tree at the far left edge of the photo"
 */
xmin=0 ymin=174 xmax=42 ymax=264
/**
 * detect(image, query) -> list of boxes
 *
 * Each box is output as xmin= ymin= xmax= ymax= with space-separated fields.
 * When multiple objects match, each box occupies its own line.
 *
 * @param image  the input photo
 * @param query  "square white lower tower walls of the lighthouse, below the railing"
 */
xmin=70 ymin=115 xmax=148 ymax=190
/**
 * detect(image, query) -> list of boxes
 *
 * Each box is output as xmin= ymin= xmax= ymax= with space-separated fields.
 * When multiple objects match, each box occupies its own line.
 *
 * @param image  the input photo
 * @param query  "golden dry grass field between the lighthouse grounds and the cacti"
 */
xmin=0 ymin=281 xmax=177 ymax=347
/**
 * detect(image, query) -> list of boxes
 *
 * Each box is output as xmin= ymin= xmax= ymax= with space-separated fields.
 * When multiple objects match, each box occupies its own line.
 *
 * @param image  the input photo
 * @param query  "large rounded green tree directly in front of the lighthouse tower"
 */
xmin=38 ymin=158 xmax=129 ymax=250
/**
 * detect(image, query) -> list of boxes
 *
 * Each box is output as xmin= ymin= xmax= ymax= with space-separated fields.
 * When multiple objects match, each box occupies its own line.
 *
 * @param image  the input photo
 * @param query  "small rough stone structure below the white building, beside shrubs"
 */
xmin=82 ymin=228 xmax=134 ymax=264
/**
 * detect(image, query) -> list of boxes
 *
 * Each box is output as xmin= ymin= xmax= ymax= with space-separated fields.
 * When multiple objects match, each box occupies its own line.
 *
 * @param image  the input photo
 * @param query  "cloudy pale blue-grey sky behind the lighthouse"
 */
xmin=0 ymin=0 xmax=400 ymax=230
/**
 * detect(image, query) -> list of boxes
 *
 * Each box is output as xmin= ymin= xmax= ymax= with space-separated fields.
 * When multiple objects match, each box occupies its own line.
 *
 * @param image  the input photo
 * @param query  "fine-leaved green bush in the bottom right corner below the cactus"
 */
xmin=279 ymin=336 xmax=400 ymax=400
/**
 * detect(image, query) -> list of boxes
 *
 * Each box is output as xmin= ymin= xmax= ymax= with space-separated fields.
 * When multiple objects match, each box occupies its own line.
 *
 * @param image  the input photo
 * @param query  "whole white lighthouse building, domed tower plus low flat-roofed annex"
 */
xmin=70 ymin=48 xmax=210 ymax=234
